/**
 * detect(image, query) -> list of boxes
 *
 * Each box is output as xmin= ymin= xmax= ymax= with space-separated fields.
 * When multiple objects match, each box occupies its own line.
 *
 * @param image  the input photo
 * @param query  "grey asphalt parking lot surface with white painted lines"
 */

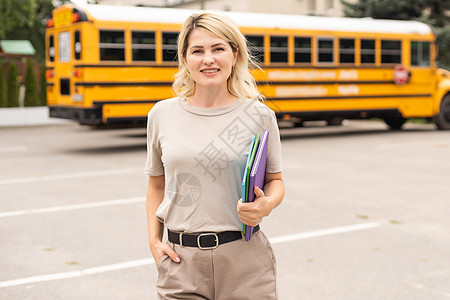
xmin=0 ymin=121 xmax=450 ymax=300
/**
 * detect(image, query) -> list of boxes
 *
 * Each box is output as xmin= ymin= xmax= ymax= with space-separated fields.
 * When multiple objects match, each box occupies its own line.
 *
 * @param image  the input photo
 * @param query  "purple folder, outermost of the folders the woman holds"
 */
xmin=245 ymin=129 xmax=269 ymax=242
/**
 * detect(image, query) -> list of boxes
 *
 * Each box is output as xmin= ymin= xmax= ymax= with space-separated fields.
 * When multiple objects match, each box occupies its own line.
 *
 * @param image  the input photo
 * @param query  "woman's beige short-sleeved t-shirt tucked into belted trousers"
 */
xmin=145 ymin=98 xmax=281 ymax=233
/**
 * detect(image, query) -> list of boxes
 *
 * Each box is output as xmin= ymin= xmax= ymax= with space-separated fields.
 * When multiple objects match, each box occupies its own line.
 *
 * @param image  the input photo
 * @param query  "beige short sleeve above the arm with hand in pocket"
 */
xmin=144 ymin=105 xmax=164 ymax=176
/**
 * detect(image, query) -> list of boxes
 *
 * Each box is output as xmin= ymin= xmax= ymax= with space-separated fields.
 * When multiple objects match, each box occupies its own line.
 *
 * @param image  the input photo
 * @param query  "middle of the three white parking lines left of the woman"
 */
xmin=0 ymin=197 xmax=145 ymax=218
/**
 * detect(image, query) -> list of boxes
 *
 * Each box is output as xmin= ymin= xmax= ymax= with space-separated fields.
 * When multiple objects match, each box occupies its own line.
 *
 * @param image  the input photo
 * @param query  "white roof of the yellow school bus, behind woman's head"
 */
xmin=80 ymin=4 xmax=432 ymax=35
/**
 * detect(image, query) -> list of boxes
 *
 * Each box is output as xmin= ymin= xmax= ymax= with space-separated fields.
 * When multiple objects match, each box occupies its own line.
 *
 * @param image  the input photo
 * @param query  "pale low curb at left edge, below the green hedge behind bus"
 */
xmin=0 ymin=106 xmax=73 ymax=127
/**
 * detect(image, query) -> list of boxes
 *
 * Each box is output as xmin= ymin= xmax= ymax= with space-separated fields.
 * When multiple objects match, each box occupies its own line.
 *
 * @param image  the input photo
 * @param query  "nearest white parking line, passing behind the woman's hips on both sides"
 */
xmin=0 ymin=223 xmax=380 ymax=288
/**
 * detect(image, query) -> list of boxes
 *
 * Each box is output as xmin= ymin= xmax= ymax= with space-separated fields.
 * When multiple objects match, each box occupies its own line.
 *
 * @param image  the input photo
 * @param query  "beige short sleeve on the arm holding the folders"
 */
xmin=266 ymin=110 xmax=282 ymax=173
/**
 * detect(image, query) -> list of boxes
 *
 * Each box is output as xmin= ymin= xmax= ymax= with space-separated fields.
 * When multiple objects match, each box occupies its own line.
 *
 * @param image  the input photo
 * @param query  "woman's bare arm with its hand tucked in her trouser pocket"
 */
xmin=146 ymin=175 xmax=180 ymax=263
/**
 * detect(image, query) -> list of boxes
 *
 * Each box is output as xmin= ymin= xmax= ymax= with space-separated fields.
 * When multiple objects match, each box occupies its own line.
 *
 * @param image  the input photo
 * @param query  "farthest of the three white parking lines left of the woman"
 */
xmin=0 ymin=168 xmax=143 ymax=185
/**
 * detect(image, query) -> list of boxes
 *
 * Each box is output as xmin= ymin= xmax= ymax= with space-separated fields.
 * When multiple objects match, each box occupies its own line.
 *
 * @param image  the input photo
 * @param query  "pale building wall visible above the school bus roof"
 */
xmin=98 ymin=0 xmax=343 ymax=16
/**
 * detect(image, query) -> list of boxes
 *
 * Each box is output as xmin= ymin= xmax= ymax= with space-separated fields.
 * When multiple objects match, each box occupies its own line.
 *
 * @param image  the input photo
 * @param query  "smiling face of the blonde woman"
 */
xmin=183 ymin=28 xmax=237 ymax=94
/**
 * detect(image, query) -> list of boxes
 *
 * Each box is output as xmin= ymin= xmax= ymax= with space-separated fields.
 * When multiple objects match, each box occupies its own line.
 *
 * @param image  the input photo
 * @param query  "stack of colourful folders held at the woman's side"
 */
xmin=242 ymin=129 xmax=269 ymax=242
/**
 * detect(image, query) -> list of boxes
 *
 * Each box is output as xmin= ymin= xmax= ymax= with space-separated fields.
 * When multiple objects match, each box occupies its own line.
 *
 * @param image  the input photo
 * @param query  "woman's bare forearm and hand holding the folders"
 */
xmin=237 ymin=172 xmax=284 ymax=226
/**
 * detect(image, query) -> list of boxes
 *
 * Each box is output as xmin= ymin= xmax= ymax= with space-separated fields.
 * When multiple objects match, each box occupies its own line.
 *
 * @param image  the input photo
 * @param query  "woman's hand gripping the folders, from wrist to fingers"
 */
xmin=237 ymin=186 xmax=273 ymax=226
